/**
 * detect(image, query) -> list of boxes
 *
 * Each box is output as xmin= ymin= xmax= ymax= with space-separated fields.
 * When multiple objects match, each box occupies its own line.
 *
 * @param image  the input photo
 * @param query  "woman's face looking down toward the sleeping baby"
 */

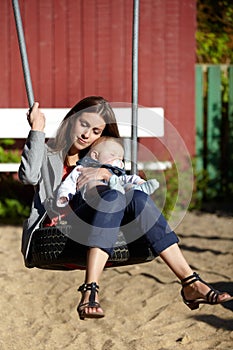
xmin=70 ymin=112 xmax=106 ymax=153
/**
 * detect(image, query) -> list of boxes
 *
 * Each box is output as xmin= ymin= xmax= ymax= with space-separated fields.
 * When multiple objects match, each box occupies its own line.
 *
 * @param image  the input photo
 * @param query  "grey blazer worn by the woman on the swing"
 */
xmin=18 ymin=130 xmax=63 ymax=265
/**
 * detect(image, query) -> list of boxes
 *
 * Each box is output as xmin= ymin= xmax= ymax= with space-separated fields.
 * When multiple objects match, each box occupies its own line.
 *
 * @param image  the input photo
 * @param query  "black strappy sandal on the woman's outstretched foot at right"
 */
xmin=181 ymin=272 xmax=233 ymax=310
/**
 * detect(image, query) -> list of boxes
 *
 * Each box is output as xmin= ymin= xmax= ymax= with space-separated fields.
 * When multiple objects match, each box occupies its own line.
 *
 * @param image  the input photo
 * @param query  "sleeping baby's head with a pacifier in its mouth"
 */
xmin=88 ymin=136 xmax=124 ymax=168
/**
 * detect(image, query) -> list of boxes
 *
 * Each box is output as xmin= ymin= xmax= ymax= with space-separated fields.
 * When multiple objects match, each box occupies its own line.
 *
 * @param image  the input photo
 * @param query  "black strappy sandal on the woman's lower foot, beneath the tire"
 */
xmin=77 ymin=282 xmax=104 ymax=320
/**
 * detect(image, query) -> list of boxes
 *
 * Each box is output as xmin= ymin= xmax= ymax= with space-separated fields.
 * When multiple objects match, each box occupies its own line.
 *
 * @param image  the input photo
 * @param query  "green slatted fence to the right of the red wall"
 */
xmin=196 ymin=65 xmax=233 ymax=197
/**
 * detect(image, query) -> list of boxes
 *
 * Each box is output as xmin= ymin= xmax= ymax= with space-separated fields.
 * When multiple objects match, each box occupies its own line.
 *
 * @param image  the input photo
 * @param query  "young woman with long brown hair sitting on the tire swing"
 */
xmin=19 ymin=96 xmax=231 ymax=319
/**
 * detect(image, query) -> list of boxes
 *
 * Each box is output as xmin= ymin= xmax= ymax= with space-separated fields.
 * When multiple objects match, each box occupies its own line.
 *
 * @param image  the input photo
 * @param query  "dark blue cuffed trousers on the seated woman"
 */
xmin=71 ymin=186 xmax=178 ymax=256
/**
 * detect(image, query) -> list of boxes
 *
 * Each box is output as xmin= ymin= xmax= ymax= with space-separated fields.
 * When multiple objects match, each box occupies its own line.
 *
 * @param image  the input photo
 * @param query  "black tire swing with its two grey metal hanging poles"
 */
xmin=12 ymin=0 xmax=155 ymax=270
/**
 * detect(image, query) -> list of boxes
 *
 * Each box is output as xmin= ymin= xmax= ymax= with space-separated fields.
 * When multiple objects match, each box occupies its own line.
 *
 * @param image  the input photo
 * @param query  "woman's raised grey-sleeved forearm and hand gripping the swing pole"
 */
xmin=18 ymin=102 xmax=45 ymax=185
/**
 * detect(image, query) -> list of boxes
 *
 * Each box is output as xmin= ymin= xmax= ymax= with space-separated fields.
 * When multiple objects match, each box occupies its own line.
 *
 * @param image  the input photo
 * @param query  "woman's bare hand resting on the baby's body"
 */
xmin=77 ymin=168 xmax=112 ymax=190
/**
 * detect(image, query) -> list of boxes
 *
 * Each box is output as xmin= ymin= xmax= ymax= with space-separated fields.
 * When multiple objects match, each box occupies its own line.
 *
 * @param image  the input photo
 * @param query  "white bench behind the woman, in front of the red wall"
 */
xmin=0 ymin=107 xmax=170 ymax=172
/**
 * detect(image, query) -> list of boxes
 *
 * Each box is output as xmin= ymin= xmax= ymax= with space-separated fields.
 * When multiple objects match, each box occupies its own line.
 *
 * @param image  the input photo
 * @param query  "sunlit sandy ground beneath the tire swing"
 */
xmin=0 ymin=213 xmax=233 ymax=350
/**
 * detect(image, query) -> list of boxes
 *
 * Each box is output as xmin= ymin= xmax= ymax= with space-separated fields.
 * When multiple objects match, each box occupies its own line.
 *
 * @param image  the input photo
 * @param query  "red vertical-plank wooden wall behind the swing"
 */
xmin=0 ymin=0 xmax=196 ymax=158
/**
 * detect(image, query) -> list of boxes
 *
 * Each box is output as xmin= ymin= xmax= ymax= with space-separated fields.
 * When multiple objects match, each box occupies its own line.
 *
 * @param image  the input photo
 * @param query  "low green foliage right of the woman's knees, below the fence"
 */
xmin=146 ymin=158 xmax=233 ymax=220
